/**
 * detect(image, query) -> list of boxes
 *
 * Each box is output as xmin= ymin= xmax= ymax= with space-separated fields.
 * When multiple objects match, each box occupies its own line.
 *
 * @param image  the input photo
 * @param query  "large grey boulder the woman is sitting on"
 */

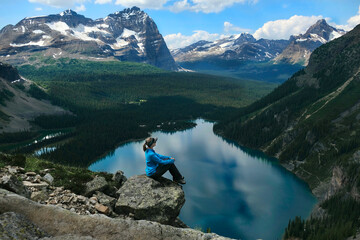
xmin=115 ymin=175 xmax=185 ymax=224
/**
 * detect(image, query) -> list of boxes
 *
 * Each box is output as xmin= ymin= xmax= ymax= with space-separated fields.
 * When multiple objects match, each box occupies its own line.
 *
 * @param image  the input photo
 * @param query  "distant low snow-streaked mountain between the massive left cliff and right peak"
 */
xmin=172 ymin=33 xmax=289 ymax=62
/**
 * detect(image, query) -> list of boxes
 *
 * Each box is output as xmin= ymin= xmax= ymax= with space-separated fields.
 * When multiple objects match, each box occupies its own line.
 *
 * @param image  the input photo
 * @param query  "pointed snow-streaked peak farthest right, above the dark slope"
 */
xmin=274 ymin=19 xmax=345 ymax=65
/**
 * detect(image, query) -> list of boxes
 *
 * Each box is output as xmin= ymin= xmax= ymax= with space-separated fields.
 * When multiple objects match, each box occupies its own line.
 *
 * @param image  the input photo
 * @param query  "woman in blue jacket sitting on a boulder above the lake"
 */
xmin=143 ymin=137 xmax=186 ymax=184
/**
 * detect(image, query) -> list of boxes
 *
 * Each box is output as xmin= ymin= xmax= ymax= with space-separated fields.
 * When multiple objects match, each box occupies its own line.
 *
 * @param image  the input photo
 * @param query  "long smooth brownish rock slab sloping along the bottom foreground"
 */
xmin=0 ymin=189 xmax=228 ymax=240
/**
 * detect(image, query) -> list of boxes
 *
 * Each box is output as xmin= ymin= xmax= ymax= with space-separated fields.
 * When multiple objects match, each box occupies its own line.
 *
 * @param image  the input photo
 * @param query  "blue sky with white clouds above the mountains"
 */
xmin=0 ymin=0 xmax=360 ymax=49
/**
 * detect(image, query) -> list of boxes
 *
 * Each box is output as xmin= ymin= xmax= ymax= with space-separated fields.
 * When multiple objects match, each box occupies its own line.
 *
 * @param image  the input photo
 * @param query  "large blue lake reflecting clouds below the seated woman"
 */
xmin=89 ymin=120 xmax=316 ymax=240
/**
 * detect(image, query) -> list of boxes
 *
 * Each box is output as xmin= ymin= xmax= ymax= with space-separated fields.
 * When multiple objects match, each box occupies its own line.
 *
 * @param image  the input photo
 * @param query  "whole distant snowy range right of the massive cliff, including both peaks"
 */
xmin=171 ymin=19 xmax=345 ymax=65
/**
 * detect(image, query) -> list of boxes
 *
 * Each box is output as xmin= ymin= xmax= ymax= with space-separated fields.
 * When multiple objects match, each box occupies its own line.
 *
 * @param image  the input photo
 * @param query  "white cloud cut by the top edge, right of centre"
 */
xmin=169 ymin=0 xmax=258 ymax=13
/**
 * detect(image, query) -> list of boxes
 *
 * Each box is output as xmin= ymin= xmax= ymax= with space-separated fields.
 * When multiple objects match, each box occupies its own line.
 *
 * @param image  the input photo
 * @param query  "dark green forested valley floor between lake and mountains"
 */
xmin=0 ymin=58 xmax=276 ymax=167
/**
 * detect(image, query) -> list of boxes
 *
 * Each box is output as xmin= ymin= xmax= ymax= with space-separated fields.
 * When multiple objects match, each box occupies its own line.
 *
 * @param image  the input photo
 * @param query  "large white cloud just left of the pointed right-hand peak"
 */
xmin=254 ymin=15 xmax=323 ymax=39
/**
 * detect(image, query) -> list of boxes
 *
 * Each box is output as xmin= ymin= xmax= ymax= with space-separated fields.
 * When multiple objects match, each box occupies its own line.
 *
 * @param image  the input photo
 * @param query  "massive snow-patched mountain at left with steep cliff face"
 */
xmin=0 ymin=7 xmax=178 ymax=70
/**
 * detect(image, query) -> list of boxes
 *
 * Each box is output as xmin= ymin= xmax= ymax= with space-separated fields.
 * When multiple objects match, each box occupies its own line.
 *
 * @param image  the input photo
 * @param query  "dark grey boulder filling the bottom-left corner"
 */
xmin=0 ymin=212 xmax=48 ymax=240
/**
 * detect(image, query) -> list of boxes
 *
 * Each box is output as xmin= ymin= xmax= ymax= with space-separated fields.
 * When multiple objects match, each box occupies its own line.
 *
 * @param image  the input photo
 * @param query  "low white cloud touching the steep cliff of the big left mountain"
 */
xmin=164 ymin=30 xmax=226 ymax=49
